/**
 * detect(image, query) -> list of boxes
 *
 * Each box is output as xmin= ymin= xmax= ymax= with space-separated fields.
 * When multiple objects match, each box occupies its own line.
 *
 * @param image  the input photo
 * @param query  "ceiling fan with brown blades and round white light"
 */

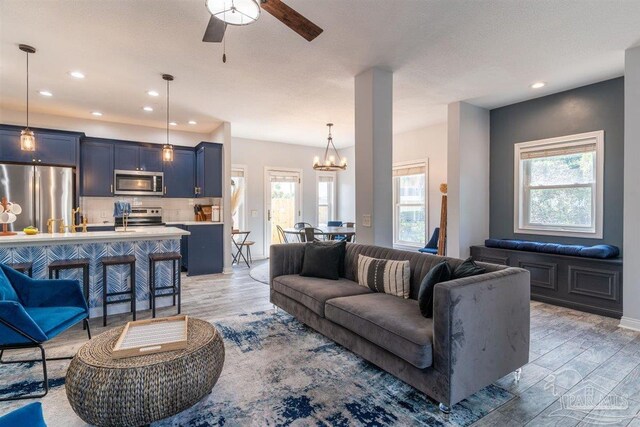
xmin=202 ymin=0 xmax=322 ymax=43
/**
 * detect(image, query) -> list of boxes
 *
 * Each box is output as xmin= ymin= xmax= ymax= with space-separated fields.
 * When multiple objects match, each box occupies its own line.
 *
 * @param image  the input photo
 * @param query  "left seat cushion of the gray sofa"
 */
xmin=273 ymin=274 xmax=371 ymax=317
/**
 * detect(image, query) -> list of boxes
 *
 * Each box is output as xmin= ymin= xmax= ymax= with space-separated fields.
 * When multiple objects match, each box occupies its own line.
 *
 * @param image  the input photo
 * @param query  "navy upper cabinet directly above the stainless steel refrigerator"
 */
xmin=0 ymin=126 xmax=82 ymax=167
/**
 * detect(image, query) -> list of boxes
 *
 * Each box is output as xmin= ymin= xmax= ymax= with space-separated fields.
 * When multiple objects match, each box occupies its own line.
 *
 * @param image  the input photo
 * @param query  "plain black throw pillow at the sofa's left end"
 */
xmin=300 ymin=242 xmax=345 ymax=280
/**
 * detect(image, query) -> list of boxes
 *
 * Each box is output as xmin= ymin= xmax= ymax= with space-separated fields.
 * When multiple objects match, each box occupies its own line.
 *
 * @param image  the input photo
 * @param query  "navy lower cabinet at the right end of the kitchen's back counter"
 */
xmin=170 ymin=224 xmax=224 ymax=276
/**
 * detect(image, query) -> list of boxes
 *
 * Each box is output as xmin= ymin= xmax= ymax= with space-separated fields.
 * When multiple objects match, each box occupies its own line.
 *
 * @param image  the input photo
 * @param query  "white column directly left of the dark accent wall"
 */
xmin=447 ymin=102 xmax=489 ymax=258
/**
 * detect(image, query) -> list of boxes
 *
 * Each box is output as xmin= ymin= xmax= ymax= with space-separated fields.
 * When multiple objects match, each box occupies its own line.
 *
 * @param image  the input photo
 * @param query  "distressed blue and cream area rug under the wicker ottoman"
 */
xmin=0 ymin=312 xmax=513 ymax=427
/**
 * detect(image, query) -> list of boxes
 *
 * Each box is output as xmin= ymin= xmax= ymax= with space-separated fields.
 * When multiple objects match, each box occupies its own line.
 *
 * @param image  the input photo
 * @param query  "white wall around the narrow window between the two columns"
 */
xmin=393 ymin=123 xmax=447 ymax=238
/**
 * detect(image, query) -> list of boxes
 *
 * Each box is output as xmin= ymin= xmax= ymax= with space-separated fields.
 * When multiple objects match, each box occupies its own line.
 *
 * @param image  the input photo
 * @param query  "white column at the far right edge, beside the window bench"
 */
xmin=620 ymin=46 xmax=640 ymax=331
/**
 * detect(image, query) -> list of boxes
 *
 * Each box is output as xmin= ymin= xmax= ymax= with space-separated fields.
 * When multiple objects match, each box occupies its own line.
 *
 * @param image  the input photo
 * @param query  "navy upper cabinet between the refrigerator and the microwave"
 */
xmin=80 ymin=139 xmax=114 ymax=197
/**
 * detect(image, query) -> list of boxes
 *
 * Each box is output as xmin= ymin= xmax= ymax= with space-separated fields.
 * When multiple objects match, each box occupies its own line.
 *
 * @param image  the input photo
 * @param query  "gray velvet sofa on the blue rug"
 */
xmin=270 ymin=243 xmax=530 ymax=411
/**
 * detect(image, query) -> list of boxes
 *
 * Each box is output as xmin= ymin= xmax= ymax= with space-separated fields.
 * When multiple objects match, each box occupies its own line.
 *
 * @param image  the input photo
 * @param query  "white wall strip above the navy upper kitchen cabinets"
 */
xmin=0 ymin=109 xmax=210 ymax=147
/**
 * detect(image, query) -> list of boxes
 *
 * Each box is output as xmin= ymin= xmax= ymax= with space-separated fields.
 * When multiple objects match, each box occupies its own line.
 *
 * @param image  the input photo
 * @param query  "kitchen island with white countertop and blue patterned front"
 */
xmin=0 ymin=227 xmax=190 ymax=317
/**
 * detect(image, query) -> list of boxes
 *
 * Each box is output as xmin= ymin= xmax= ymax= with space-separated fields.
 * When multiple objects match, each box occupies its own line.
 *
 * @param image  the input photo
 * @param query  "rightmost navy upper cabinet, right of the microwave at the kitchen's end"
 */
xmin=196 ymin=142 xmax=222 ymax=197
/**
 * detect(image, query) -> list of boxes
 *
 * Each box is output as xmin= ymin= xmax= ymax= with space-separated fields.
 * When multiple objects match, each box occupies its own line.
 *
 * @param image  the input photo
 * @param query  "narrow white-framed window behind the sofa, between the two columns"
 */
xmin=393 ymin=162 xmax=427 ymax=247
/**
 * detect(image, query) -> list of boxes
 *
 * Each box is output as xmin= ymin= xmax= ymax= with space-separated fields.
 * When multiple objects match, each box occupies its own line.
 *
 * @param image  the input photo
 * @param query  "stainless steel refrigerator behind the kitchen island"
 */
xmin=0 ymin=164 xmax=75 ymax=232
